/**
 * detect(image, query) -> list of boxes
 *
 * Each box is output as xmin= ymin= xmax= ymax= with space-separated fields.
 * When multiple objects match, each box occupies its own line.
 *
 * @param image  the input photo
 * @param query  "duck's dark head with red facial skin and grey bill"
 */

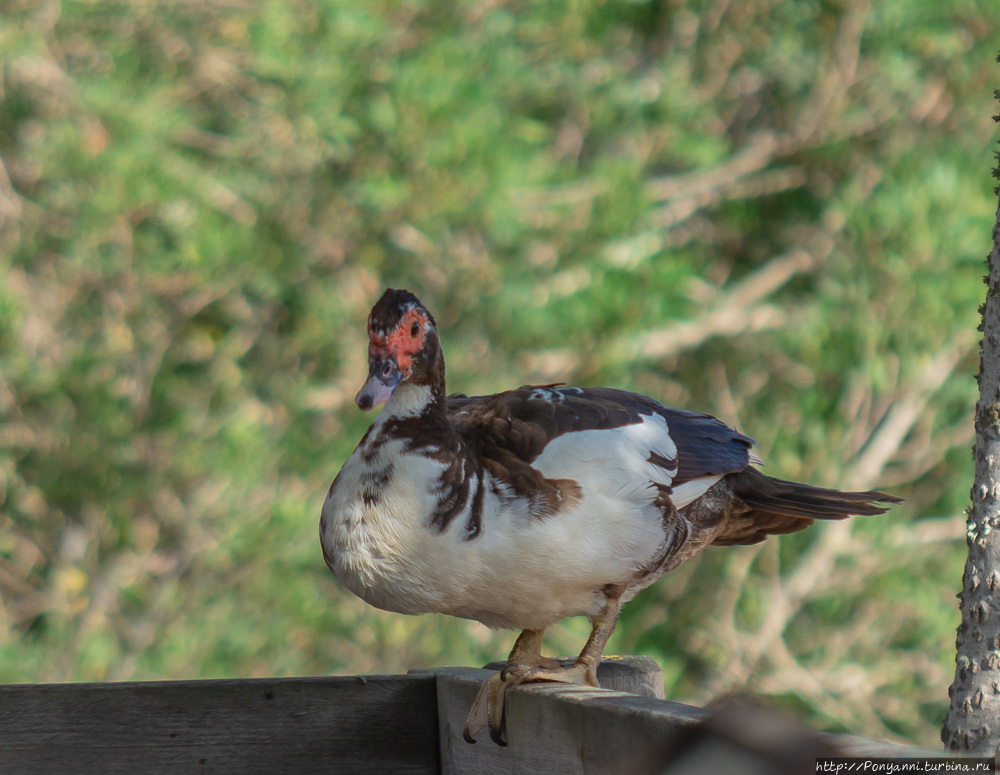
xmin=354 ymin=288 xmax=444 ymax=412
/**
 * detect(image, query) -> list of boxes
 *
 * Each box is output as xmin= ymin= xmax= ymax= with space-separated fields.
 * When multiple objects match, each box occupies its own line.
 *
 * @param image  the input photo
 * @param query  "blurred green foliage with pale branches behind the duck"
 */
xmin=0 ymin=0 xmax=1000 ymax=745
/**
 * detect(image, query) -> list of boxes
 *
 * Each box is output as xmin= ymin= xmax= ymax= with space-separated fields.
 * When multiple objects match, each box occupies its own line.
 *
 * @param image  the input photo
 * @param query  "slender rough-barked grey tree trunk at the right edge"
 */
xmin=941 ymin=83 xmax=1000 ymax=756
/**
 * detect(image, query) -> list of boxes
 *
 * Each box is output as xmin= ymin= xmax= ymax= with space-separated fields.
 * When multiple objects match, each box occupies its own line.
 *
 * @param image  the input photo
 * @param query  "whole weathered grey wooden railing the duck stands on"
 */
xmin=0 ymin=657 xmax=940 ymax=775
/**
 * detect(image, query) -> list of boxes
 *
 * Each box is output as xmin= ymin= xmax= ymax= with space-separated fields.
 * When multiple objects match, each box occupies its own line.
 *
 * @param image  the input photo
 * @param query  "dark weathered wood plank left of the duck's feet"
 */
xmin=0 ymin=675 xmax=439 ymax=775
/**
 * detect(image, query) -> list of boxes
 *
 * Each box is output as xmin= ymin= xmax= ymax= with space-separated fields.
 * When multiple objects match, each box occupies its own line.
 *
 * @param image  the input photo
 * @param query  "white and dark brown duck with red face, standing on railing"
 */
xmin=319 ymin=288 xmax=901 ymax=745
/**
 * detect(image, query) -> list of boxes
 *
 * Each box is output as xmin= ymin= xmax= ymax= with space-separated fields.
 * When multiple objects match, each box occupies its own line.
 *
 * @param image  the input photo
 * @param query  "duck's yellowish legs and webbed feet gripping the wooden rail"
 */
xmin=464 ymin=585 xmax=624 ymax=745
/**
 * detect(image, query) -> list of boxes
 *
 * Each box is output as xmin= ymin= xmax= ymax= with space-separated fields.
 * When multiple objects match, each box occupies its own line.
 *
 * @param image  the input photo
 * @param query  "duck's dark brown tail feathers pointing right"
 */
xmin=713 ymin=468 xmax=903 ymax=546
